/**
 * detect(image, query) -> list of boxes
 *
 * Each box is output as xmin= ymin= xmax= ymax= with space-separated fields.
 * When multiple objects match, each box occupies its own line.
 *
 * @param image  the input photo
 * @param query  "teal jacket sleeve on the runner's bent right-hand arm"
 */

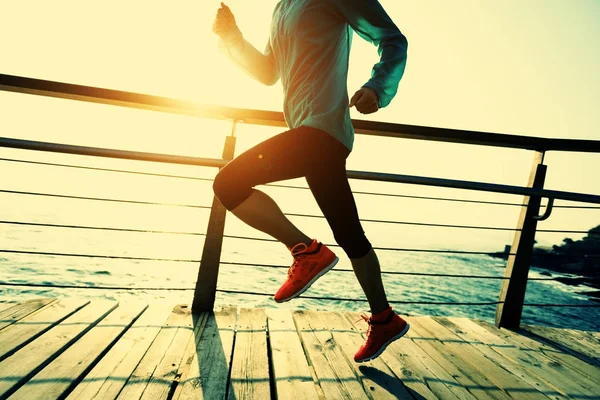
xmin=331 ymin=0 xmax=408 ymax=107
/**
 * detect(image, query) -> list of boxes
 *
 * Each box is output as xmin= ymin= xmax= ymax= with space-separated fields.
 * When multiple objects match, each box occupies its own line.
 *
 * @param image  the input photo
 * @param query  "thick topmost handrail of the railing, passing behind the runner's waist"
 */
xmin=0 ymin=74 xmax=600 ymax=153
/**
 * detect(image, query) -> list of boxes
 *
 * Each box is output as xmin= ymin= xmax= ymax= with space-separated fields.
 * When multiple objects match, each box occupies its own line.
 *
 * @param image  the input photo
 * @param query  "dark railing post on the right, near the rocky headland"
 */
xmin=496 ymin=151 xmax=546 ymax=330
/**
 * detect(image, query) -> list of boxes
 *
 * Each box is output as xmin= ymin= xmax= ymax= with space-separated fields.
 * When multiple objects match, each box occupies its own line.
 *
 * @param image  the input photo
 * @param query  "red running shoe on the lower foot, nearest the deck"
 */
xmin=354 ymin=311 xmax=410 ymax=362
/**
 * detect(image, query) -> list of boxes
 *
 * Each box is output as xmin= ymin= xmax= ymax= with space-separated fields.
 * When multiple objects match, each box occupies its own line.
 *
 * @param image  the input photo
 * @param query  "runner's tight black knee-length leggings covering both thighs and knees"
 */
xmin=213 ymin=126 xmax=371 ymax=259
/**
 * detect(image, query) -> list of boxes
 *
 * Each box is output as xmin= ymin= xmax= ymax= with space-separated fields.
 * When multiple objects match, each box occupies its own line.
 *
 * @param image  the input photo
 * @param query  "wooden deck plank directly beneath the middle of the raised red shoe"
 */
xmin=293 ymin=311 xmax=367 ymax=399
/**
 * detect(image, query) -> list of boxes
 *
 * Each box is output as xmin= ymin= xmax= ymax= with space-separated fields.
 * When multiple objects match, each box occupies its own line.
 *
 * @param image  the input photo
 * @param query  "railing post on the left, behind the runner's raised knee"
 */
xmin=192 ymin=121 xmax=237 ymax=313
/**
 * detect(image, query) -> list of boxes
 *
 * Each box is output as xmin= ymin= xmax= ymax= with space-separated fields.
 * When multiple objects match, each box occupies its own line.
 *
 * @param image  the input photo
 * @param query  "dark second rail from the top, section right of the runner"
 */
xmin=348 ymin=171 xmax=600 ymax=204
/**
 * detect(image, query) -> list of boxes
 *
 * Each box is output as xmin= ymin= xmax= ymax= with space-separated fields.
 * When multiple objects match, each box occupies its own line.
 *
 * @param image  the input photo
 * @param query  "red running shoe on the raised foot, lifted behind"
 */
xmin=275 ymin=239 xmax=339 ymax=303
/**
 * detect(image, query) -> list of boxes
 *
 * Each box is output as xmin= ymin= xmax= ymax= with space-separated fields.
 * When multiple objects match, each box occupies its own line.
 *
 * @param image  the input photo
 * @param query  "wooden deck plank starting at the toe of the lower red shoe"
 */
xmin=409 ymin=317 xmax=511 ymax=400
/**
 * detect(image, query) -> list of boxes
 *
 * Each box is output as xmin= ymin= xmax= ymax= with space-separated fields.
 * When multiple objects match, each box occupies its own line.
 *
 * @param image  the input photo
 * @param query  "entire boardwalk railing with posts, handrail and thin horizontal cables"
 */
xmin=0 ymin=74 xmax=600 ymax=328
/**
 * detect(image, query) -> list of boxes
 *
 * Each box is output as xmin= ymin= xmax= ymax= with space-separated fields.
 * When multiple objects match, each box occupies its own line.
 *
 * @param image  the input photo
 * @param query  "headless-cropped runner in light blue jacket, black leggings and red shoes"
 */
xmin=213 ymin=0 xmax=409 ymax=362
